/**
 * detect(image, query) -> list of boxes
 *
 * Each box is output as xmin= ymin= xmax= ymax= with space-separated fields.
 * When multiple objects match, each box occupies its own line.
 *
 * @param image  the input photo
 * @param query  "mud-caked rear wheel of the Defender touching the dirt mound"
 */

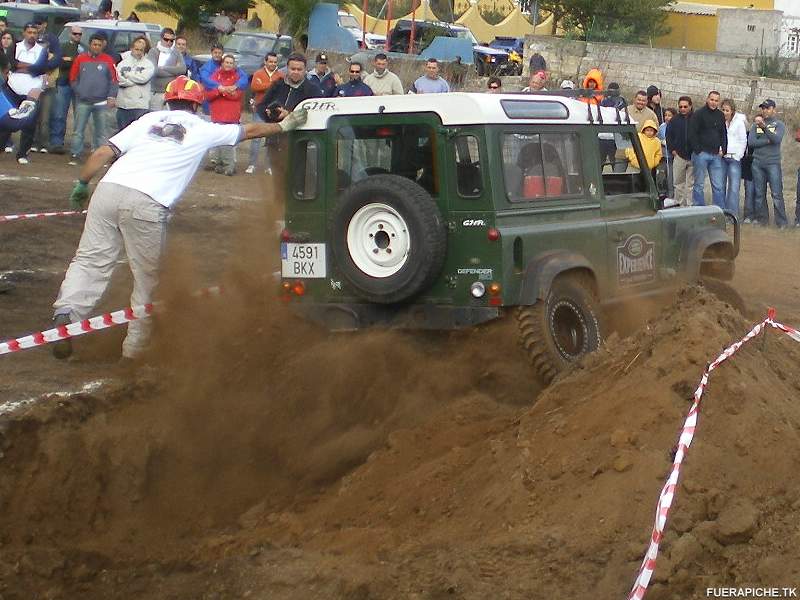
xmin=517 ymin=277 xmax=602 ymax=385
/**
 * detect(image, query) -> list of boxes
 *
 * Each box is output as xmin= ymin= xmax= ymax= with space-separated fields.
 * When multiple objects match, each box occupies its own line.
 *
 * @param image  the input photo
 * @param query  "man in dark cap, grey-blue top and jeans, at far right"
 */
xmin=747 ymin=98 xmax=788 ymax=229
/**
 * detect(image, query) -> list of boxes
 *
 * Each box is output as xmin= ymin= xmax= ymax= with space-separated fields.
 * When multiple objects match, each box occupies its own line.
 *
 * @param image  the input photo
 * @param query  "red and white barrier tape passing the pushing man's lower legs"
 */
xmin=0 ymin=286 xmax=223 ymax=355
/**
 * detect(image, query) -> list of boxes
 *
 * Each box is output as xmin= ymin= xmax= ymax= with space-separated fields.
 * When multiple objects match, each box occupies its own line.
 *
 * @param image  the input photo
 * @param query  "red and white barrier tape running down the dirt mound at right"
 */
xmin=628 ymin=308 xmax=800 ymax=600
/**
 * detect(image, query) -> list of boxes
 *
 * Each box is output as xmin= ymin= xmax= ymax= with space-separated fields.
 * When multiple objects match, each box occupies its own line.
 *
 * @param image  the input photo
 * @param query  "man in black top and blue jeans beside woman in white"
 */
xmin=689 ymin=90 xmax=728 ymax=208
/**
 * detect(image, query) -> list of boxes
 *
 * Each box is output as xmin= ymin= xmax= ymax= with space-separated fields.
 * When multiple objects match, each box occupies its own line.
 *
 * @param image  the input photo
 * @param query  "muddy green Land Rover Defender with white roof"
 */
xmin=280 ymin=93 xmax=739 ymax=383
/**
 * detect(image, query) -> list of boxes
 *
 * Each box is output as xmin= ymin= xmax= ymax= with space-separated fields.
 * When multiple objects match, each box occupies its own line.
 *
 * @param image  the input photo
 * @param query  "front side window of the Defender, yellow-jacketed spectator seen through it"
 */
xmin=597 ymin=131 xmax=649 ymax=198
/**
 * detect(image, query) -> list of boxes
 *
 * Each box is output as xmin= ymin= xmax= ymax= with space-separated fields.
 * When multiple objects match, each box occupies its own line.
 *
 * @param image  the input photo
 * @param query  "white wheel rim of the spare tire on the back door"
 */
xmin=347 ymin=203 xmax=411 ymax=278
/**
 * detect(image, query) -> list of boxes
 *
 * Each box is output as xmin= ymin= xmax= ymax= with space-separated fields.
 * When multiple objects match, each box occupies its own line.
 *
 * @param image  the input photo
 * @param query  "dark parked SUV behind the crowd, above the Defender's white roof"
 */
xmin=389 ymin=19 xmax=508 ymax=75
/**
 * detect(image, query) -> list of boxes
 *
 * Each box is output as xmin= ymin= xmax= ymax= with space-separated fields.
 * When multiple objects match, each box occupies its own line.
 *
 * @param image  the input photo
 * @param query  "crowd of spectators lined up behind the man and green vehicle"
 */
xmin=0 ymin=24 xmax=800 ymax=228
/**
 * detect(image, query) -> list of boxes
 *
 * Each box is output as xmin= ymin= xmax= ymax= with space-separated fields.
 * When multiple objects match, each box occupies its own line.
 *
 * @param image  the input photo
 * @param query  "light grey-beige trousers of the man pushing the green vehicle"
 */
xmin=53 ymin=182 xmax=170 ymax=358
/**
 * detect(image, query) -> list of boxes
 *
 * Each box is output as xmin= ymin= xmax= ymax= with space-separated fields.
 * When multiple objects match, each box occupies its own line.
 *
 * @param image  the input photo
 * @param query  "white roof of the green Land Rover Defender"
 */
xmin=294 ymin=92 xmax=635 ymax=129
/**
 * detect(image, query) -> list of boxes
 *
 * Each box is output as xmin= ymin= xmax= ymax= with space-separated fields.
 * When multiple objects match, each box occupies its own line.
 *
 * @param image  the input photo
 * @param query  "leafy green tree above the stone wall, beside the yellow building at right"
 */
xmin=539 ymin=0 xmax=671 ymax=43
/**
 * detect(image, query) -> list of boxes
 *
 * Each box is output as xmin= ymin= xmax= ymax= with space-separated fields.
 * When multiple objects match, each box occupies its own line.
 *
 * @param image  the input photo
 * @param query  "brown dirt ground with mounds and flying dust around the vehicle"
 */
xmin=0 ymin=155 xmax=800 ymax=600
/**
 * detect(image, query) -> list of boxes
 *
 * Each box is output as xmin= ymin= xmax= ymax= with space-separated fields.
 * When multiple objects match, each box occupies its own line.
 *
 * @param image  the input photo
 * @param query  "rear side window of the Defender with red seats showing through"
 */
xmin=503 ymin=133 xmax=584 ymax=202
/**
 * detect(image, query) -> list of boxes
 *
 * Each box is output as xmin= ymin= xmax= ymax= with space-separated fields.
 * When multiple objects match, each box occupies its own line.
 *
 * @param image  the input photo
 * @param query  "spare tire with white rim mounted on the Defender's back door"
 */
xmin=328 ymin=175 xmax=447 ymax=304
